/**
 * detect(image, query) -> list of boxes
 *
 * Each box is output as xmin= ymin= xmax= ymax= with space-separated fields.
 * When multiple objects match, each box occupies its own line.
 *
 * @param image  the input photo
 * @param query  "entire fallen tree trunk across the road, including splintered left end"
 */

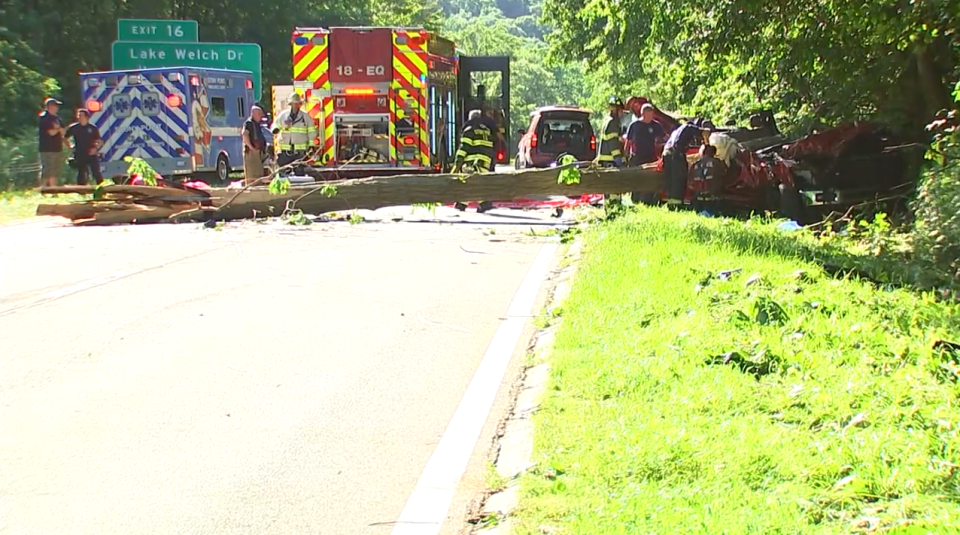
xmin=37 ymin=164 xmax=660 ymax=224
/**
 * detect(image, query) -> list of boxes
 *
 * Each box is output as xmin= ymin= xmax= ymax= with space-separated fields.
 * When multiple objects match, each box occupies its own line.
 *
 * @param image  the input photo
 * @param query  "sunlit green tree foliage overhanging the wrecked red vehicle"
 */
xmin=544 ymin=0 xmax=960 ymax=136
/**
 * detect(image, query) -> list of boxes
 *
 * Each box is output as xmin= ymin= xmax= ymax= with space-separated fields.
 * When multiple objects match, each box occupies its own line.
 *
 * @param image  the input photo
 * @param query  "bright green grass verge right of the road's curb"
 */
xmin=517 ymin=209 xmax=960 ymax=535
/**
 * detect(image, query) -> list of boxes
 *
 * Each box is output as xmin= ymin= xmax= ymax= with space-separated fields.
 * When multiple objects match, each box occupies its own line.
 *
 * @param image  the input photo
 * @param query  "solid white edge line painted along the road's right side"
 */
xmin=393 ymin=243 xmax=558 ymax=535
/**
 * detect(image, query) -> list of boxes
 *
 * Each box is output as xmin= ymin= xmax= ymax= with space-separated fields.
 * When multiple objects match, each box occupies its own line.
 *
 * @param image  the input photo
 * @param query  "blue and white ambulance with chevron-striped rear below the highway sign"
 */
xmin=80 ymin=67 xmax=255 ymax=183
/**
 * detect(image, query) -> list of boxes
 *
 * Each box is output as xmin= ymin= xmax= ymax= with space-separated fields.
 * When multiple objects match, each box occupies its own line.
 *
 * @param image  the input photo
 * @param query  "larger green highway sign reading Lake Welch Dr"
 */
xmin=112 ymin=41 xmax=261 ymax=100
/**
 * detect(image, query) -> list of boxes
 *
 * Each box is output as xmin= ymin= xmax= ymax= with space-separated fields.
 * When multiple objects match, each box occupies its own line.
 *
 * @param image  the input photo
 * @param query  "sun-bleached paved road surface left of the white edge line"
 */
xmin=0 ymin=209 xmax=568 ymax=535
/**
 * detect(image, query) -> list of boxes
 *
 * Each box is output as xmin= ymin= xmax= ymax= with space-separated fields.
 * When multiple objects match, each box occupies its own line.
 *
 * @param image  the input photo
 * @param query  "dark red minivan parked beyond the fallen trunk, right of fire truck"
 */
xmin=514 ymin=106 xmax=597 ymax=169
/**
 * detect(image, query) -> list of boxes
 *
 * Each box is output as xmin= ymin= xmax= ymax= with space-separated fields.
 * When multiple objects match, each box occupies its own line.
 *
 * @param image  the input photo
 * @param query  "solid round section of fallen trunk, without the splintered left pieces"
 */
xmin=211 ymin=166 xmax=660 ymax=219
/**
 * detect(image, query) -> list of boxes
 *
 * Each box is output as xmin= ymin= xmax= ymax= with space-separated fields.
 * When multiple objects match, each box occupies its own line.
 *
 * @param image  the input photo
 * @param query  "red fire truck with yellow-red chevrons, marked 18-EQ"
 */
xmin=282 ymin=27 xmax=510 ymax=177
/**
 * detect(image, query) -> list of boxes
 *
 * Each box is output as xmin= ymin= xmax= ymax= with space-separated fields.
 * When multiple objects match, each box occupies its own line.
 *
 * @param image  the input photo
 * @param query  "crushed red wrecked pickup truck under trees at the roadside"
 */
xmin=631 ymin=97 xmax=915 ymax=223
